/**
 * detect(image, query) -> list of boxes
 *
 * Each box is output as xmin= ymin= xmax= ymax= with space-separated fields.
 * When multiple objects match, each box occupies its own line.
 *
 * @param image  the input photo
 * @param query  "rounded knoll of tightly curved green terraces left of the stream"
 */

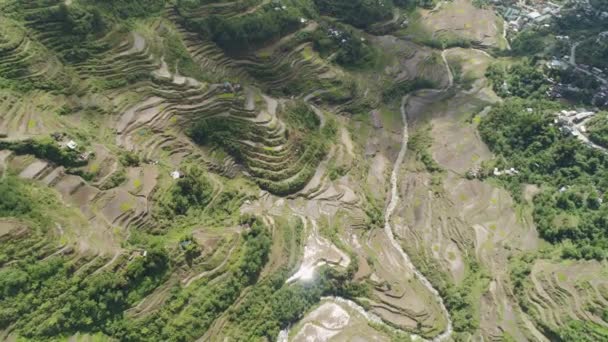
xmin=188 ymin=102 xmax=336 ymax=195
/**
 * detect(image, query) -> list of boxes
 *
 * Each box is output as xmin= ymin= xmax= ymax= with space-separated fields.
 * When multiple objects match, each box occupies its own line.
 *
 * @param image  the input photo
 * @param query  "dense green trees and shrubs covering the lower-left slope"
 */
xmin=0 ymin=202 xmax=271 ymax=341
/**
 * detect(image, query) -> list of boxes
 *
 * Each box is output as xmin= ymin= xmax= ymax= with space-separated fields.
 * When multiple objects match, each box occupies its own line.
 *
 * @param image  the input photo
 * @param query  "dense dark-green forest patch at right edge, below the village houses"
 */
xmin=479 ymin=98 xmax=608 ymax=259
